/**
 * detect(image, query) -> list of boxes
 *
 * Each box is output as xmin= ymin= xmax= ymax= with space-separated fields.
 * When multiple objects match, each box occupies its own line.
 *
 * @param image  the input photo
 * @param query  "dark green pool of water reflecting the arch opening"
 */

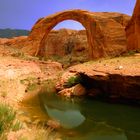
xmin=39 ymin=90 xmax=140 ymax=140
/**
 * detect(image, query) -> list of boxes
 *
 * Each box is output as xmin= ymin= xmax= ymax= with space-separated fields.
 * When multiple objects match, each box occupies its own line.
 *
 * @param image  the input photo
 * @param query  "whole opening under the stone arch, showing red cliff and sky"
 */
xmin=39 ymin=20 xmax=88 ymax=62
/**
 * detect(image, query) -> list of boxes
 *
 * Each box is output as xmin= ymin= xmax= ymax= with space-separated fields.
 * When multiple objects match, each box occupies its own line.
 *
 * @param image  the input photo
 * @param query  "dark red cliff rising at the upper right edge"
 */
xmin=126 ymin=0 xmax=140 ymax=51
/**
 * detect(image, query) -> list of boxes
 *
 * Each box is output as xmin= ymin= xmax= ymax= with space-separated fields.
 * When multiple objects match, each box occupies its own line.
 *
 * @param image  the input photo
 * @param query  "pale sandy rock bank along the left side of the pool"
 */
xmin=0 ymin=54 xmax=62 ymax=140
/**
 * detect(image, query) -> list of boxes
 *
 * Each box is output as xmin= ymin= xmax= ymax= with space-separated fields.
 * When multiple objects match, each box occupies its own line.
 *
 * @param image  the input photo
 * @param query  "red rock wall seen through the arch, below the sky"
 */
xmin=39 ymin=29 xmax=88 ymax=57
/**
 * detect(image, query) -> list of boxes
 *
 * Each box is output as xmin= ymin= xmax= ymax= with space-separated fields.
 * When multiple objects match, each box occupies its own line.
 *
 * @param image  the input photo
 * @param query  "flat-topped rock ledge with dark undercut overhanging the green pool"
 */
xmin=56 ymin=54 xmax=140 ymax=100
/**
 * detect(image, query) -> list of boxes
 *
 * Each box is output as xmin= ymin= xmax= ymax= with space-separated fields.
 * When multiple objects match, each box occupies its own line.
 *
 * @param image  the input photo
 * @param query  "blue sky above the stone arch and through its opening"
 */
xmin=0 ymin=0 xmax=136 ymax=30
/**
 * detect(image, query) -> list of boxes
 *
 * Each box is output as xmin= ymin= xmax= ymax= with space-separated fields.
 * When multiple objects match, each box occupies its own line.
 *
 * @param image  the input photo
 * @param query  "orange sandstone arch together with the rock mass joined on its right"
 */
xmin=0 ymin=10 xmax=130 ymax=59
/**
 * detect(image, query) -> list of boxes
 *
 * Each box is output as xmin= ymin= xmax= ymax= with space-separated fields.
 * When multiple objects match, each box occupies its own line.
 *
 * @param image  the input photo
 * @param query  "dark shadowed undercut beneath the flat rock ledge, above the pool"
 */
xmin=79 ymin=73 xmax=140 ymax=104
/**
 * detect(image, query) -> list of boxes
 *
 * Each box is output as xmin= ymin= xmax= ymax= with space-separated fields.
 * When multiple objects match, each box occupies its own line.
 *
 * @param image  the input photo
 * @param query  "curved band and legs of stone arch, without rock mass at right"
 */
xmin=29 ymin=10 xmax=105 ymax=58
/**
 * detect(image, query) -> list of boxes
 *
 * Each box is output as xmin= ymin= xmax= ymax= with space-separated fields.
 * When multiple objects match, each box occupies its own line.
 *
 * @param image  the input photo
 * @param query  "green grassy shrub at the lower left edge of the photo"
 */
xmin=0 ymin=103 xmax=22 ymax=138
